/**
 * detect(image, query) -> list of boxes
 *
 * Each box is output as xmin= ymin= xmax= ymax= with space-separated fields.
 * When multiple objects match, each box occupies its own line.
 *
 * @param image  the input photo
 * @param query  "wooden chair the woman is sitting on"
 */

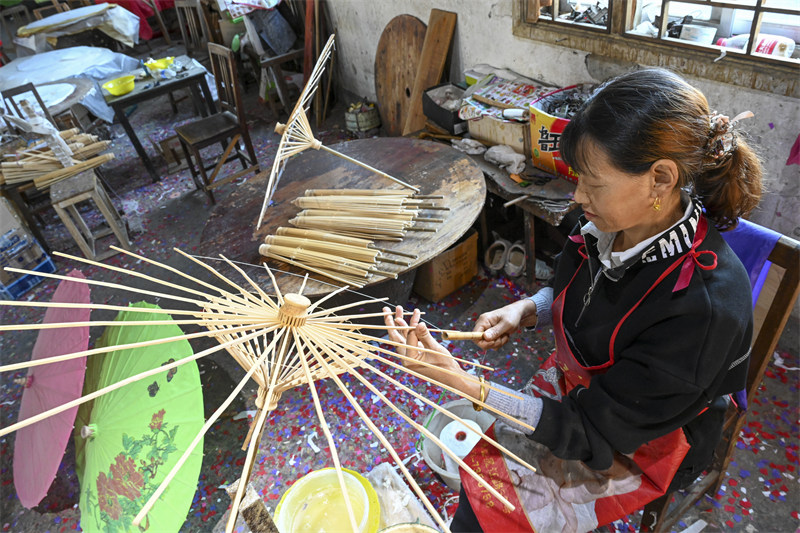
xmin=640 ymin=221 xmax=800 ymax=532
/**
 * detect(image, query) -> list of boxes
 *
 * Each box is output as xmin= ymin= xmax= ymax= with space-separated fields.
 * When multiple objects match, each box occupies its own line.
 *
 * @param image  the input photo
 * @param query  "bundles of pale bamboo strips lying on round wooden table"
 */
xmin=259 ymin=189 xmax=448 ymax=287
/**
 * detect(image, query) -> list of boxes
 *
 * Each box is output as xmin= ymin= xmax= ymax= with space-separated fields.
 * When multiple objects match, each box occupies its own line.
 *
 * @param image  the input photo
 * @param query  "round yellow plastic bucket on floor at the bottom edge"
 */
xmin=275 ymin=468 xmax=381 ymax=533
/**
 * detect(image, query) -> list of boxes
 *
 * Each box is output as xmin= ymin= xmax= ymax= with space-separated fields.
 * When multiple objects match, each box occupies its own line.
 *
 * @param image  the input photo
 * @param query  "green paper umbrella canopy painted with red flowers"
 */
xmin=75 ymin=302 xmax=204 ymax=533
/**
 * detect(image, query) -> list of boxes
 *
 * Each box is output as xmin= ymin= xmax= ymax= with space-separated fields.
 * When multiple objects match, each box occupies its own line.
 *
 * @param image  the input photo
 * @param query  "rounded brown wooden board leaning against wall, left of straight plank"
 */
xmin=375 ymin=15 xmax=426 ymax=137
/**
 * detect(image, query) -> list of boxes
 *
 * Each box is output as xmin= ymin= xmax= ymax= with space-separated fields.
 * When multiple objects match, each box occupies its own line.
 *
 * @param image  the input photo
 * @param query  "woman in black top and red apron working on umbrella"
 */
xmin=384 ymin=69 xmax=761 ymax=532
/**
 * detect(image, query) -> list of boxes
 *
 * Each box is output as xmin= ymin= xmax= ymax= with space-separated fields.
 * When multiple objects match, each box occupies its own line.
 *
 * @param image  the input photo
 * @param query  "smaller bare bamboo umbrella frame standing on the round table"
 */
xmin=256 ymin=34 xmax=419 ymax=228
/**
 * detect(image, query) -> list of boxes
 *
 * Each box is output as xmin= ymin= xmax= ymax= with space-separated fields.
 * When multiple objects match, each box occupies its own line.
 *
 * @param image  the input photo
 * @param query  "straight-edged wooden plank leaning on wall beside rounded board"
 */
xmin=403 ymin=9 xmax=457 ymax=135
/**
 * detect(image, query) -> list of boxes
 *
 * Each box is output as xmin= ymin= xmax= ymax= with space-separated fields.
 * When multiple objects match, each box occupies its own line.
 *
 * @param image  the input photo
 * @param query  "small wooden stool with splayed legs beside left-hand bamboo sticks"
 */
xmin=50 ymin=170 xmax=131 ymax=261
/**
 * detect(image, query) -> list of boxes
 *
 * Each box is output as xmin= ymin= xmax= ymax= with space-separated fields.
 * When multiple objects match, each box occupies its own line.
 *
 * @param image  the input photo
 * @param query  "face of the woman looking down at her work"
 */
xmin=575 ymin=141 xmax=652 ymax=239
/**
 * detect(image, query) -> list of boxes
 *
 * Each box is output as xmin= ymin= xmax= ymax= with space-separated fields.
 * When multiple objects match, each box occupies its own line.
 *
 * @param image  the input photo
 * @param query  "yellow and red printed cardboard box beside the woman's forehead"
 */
xmin=526 ymin=85 xmax=588 ymax=183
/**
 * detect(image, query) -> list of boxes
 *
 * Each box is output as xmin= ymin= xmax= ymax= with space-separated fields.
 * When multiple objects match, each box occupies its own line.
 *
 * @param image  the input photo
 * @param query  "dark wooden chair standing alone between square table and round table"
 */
xmin=175 ymin=43 xmax=260 ymax=203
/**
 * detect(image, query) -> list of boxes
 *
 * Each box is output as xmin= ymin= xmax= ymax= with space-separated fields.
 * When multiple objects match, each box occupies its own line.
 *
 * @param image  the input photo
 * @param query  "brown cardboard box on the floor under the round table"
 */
xmin=414 ymin=229 xmax=478 ymax=302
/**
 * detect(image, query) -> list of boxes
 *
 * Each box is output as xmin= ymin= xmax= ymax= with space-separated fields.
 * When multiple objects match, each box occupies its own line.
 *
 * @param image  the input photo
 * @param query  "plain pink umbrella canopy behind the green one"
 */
xmin=14 ymin=270 xmax=91 ymax=509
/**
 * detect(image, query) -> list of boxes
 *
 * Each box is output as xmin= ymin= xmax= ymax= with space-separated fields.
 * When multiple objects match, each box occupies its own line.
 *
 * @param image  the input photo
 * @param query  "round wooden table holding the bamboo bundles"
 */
xmin=198 ymin=137 xmax=486 ymax=296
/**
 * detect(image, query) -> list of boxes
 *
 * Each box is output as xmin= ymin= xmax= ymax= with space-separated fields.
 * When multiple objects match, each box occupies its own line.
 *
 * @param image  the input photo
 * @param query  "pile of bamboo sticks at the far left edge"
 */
xmin=0 ymin=128 xmax=114 ymax=189
